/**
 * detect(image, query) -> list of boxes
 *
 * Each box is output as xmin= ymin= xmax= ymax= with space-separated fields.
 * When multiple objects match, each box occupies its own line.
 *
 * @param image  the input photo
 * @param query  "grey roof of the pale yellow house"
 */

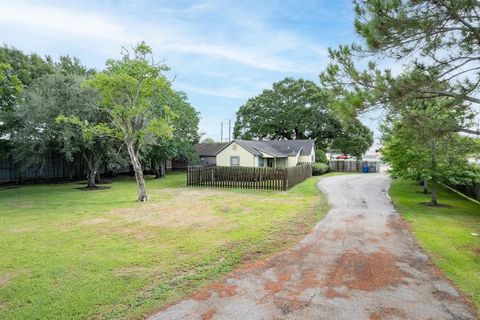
xmin=217 ymin=139 xmax=314 ymax=158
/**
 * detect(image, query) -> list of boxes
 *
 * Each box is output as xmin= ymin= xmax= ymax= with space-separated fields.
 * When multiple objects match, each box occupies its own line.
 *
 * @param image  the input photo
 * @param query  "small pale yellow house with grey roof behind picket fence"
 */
xmin=216 ymin=139 xmax=315 ymax=168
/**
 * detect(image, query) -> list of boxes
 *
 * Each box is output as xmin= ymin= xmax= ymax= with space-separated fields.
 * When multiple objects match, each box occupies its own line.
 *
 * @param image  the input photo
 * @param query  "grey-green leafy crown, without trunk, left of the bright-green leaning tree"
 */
xmin=11 ymin=73 xmax=97 ymax=168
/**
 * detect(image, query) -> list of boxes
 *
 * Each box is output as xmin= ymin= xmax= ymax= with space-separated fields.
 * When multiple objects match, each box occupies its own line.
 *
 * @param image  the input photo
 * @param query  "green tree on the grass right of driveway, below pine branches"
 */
xmin=382 ymin=98 xmax=480 ymax=206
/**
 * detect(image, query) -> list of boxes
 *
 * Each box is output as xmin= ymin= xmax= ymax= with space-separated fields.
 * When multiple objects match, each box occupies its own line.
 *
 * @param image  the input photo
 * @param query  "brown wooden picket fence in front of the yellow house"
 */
xmin=187 ymin=164 xmax=312 ymax=190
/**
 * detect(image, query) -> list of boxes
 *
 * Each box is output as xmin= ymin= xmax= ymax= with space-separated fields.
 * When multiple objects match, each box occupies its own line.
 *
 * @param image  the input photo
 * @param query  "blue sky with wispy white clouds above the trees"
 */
xmin=0 ymin=0 xmax=384 ymax=144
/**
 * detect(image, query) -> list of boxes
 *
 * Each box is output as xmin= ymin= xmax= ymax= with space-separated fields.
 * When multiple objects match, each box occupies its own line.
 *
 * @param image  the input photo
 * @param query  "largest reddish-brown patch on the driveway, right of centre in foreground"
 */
xmin=325 ymin=252 xmax=403 ymax=291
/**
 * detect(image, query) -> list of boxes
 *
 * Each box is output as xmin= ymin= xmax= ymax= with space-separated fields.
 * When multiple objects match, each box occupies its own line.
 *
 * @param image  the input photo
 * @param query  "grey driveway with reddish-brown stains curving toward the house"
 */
xmin=151 ymin=174 xmax=476 ymax=320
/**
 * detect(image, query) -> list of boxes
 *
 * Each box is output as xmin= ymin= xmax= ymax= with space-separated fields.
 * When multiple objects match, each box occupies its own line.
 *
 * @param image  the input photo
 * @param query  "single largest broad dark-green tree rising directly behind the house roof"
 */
xmin=233 ymin=78 xmax=341 ymax=148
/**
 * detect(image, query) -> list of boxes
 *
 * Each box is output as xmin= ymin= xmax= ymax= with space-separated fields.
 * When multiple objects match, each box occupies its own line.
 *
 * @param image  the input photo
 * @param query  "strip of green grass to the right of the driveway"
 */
xmin=390 ymin=180 xmax=480 ymax=309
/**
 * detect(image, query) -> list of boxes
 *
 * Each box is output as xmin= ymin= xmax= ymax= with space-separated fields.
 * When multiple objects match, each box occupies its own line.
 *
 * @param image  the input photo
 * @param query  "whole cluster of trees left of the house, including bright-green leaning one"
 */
xmin=0 ymin=43 xmax=199 ymax=201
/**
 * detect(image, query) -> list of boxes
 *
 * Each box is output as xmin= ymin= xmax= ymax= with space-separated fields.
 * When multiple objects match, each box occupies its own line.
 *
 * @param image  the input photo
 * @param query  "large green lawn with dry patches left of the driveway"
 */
xmin=0 ymin=173 xmax=328 ymax=319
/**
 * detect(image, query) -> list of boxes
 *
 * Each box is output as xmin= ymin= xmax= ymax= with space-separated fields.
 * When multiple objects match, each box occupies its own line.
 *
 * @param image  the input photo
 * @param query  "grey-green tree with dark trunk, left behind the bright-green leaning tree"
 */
xmin=11 ymin=70 xmax=121 ymax=188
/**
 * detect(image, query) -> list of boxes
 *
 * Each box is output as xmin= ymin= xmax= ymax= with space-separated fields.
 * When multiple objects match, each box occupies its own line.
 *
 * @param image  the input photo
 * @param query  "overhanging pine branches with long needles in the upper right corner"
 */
xmin=321 ymin=0 xmax=480 ymax=134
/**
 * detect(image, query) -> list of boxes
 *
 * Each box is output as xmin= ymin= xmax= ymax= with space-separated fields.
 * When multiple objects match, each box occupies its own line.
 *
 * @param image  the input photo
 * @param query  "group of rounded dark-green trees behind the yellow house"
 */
xmin=233 ymin=78 xmax=373 ymax=159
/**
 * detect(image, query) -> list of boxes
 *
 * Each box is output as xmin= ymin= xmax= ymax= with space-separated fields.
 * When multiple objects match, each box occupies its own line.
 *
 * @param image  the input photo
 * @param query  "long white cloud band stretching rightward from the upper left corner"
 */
xmin=0 ymin=2 xmax=326 ymax=73
